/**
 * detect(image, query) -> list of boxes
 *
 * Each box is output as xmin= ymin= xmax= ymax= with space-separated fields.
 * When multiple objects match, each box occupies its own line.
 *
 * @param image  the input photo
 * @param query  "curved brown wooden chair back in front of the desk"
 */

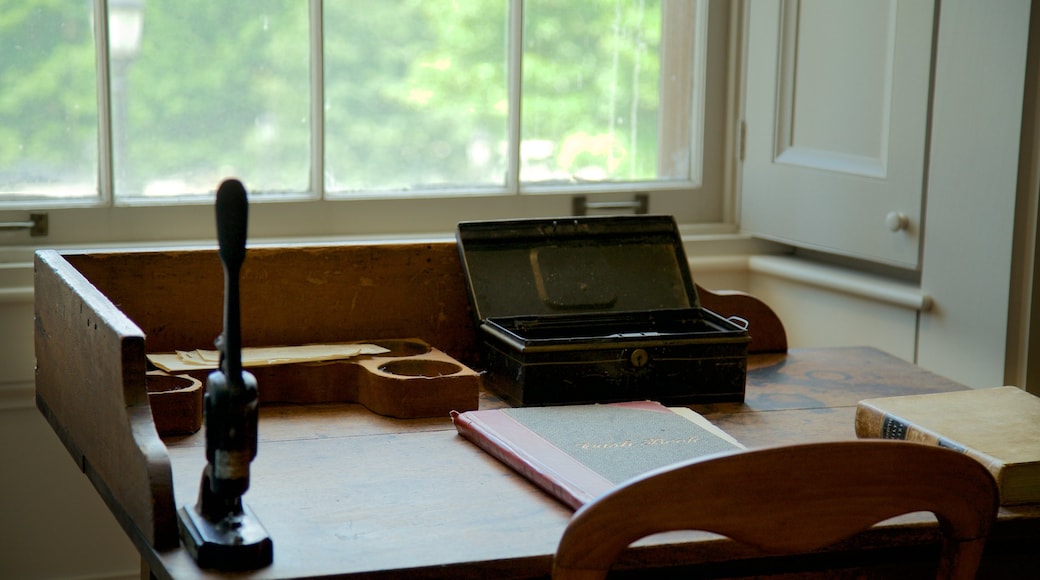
xmin=553 ymin=440 xmax=998 ymax=580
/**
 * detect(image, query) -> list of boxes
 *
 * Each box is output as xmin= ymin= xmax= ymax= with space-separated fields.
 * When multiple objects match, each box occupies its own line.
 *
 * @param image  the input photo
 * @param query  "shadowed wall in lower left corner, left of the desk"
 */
xmin=0 ymin=280 xmax=140 ymax=580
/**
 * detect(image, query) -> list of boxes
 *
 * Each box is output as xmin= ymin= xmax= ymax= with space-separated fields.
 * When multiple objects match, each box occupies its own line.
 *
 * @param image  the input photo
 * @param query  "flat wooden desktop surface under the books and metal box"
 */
xmin=83 ymin=348 xmax=1040 ymax=578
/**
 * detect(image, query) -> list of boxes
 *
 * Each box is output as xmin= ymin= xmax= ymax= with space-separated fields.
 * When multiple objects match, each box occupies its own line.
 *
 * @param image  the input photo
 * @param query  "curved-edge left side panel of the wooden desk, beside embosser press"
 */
xmin=34 ymin=251 xmax=178 ymax=548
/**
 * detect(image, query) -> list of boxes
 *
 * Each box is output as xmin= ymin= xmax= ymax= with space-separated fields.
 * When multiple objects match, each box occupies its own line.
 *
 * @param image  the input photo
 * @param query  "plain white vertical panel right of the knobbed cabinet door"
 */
xmin=917 ymin=0 xmax=1030 ymax=387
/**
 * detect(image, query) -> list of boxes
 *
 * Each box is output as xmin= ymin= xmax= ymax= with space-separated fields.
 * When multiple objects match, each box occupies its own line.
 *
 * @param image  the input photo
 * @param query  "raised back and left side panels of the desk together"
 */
xmin=35 ymin=242 xmax=477 ymax=549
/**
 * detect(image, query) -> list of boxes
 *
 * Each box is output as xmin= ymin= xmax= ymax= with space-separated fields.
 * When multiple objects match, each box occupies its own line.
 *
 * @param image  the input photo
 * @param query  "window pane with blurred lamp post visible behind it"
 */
xmin=116 ymin=0 xmax=310 ymax=200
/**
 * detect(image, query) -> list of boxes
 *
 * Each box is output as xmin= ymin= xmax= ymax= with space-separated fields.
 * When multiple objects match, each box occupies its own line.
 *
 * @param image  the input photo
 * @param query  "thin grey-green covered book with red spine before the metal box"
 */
xmin=451 ymin=401 xmax=744 ymax=509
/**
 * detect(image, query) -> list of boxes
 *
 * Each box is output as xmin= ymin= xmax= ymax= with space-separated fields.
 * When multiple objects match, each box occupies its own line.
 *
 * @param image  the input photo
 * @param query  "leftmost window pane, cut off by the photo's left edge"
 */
xmin=0 ymin=0 xmax=98 ymax=203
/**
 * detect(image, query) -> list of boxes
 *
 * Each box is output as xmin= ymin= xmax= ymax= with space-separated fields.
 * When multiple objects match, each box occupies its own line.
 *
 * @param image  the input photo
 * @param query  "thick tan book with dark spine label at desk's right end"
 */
xmin=856 ymin=387 xmax=1040 ymax=505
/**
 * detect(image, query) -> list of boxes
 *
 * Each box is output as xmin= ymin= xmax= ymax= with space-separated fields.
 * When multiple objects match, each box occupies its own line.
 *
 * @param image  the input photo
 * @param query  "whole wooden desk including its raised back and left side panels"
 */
xmin=28 ymin=242 xmax=1040 ymax=578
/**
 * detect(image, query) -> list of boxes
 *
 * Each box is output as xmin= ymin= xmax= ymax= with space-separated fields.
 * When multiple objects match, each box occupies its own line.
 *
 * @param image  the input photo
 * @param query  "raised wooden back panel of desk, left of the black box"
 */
xmin=67 ymin=242 xmax=478 ymax=366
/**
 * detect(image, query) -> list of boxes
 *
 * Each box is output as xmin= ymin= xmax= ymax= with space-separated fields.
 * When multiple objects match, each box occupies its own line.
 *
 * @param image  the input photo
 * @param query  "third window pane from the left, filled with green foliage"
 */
xmin=324 ymin=0 xmax=509 ymax=194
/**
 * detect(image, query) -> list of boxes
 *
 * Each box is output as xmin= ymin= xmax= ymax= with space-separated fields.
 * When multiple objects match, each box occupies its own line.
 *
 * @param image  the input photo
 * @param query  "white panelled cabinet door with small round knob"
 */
xmin=740 ymin=0 xmax=935 ymax=268
